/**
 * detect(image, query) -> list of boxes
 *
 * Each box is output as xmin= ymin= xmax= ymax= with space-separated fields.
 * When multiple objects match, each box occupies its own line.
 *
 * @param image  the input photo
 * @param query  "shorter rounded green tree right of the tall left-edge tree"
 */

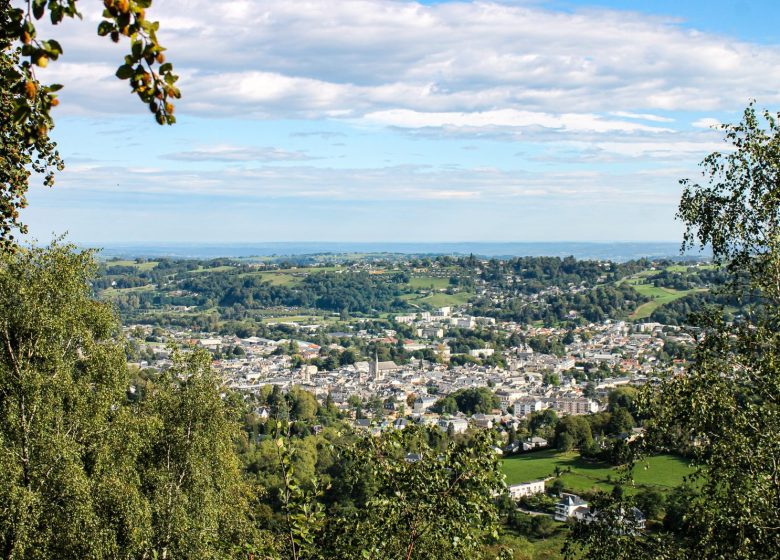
xmin=137 ymin=350 xmax=253 ymax=558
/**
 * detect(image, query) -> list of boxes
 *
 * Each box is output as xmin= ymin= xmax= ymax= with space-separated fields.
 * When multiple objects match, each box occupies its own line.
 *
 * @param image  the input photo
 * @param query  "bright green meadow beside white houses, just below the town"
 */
xmin=502 ymin=449 xmax=693 ymax=492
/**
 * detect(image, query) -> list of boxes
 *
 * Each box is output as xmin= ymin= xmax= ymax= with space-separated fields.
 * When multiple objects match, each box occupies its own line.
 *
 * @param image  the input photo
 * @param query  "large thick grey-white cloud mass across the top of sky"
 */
xmin=33 ymin=0 xmax=780 ymax=121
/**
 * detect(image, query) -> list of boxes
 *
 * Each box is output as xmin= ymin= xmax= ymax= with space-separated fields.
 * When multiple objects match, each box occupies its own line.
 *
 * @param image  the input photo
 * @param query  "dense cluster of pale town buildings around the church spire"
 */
xmin=122 ymin=307 xmax=688 ymax=436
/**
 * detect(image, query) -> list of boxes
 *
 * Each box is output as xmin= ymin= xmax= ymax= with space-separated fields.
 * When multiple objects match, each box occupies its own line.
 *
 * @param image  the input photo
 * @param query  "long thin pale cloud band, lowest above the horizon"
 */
xmin=45 ymin=161 xmax=679 ymax=207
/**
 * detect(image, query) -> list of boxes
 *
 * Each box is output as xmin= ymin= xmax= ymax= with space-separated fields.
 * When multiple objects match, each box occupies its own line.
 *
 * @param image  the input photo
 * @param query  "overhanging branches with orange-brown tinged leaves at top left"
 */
xmin=0 ymin=0 xmax=181 ymax=249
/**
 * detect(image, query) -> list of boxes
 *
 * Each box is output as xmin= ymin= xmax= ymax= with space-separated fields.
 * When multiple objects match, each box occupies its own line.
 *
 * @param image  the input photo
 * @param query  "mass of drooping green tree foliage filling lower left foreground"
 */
xmin=0 ymin=243 xmax=258 ymax=559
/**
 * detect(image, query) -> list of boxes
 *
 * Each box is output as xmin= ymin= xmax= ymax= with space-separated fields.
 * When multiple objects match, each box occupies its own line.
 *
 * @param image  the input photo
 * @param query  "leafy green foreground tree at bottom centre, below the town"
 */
xmin=321 ymin=427 xmax=505 ymax=560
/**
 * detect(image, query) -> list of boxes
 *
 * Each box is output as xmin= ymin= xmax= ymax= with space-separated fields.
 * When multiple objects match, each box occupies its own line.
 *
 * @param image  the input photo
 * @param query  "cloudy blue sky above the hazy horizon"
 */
xmin=22 ymin=0 xmax=780 ymax=244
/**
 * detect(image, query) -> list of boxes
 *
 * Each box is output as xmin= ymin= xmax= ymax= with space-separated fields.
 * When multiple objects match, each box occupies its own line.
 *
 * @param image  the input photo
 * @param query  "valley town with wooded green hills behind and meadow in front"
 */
xmin=102 ymin=253 xmax=712 ymax=533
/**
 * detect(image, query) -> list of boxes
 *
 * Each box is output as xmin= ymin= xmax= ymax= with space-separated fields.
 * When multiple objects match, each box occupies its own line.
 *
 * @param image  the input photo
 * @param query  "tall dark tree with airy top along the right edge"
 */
xmin=569 ymin=104 xmax=780 ymax=559
